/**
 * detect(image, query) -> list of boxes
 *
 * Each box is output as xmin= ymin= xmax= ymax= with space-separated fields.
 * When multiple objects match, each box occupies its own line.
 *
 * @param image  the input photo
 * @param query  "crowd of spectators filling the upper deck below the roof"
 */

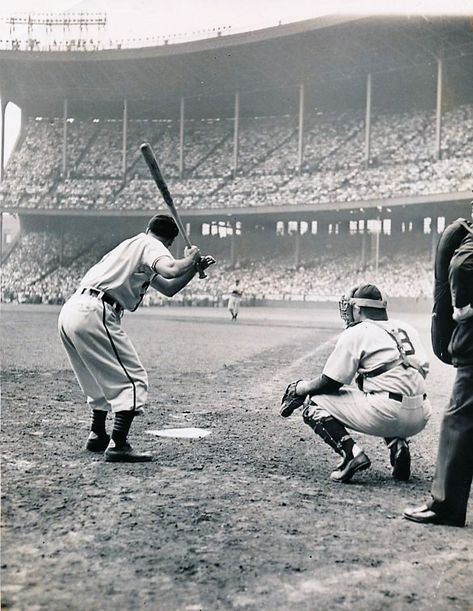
xmin=0 ymin=105 xmax=473 ymax=209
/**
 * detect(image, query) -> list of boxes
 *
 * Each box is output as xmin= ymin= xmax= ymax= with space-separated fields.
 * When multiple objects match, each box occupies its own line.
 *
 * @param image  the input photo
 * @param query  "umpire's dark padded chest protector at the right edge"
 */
xmin=431 ymin=219 xmax=473 ymax=365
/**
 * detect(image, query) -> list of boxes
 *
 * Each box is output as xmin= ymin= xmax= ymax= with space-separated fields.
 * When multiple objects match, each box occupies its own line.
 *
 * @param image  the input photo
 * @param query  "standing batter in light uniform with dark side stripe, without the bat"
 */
xmin=58 ymin=214 xmax=215 ymax=462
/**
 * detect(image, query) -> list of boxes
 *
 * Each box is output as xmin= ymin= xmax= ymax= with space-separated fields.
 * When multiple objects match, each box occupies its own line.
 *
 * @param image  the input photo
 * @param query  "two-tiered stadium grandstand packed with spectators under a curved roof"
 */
xmin=0 ymin=16 xmax=473 ymax=306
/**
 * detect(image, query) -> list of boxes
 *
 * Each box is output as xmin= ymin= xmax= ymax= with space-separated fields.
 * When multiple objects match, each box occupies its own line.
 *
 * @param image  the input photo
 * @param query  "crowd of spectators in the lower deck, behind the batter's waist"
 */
xmin=1 ymin=232 xmax=432 ymax=305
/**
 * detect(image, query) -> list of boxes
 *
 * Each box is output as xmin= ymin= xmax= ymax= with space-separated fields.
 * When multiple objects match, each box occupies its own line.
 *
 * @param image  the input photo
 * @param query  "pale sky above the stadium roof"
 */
xmin=0 ymin=0 xmax=473 ymax=38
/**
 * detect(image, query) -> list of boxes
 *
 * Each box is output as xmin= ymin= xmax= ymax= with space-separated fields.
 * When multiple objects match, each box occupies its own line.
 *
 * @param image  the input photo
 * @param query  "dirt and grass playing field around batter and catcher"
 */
xmin=1 ymin=306 xmax=473 ymax=611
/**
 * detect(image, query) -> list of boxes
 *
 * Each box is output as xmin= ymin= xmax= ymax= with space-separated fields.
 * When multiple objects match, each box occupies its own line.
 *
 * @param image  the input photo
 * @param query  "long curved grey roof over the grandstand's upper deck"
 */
xmin=0 ymin=16 xmax=473 ymax=118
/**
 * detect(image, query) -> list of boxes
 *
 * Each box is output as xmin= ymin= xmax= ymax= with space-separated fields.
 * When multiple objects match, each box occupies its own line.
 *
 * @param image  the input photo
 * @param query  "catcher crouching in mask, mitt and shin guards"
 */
xmin=280 ymin=284 xmax=431 ymax=482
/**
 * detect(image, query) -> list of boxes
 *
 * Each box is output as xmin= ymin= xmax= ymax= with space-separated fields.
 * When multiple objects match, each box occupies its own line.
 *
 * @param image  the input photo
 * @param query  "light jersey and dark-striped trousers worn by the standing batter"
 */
xmin=58 ymin=232 xmax=173 ymax=412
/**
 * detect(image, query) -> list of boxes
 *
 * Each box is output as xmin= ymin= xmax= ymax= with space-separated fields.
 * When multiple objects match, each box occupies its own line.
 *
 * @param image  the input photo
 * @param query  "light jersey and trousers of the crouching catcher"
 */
xmin=308 ymin=320 xmax=431 ymax=438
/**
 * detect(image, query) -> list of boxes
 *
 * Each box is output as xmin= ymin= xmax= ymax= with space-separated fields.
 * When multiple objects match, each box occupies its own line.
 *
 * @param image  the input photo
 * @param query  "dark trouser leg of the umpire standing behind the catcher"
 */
xmin=429 ymin=365 xmax=473 ymax=522
